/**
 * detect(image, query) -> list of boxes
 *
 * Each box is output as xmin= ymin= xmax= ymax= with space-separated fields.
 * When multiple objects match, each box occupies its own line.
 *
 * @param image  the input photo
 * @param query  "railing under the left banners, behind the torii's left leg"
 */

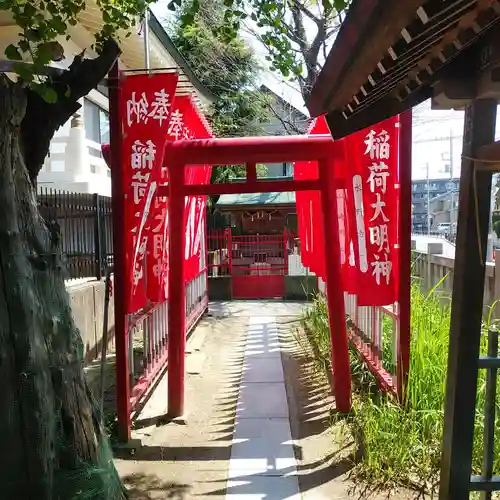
xmin=128 ymin=269 xmax=208 ymax=411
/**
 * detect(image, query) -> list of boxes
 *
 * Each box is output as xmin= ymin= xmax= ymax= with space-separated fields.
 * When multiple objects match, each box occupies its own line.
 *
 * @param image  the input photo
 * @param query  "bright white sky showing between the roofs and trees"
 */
xmin=152 ymin=0 xmax=500 ymax=179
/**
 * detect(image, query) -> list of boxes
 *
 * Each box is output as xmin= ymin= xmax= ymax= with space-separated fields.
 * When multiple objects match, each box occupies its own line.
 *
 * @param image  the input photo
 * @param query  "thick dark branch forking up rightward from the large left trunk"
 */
xmin=21 ymin=40 xmax=120 ymax=183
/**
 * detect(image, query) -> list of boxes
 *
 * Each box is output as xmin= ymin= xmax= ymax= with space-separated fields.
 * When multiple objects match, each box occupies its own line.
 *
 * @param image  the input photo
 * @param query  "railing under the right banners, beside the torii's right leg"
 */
xmin=344 ymin=293 xmax=402 ymax=394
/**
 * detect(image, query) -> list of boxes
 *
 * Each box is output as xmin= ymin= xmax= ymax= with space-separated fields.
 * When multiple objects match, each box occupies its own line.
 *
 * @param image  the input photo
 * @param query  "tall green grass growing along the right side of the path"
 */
xmin=303 ymin=284 xmax=500 ymax=488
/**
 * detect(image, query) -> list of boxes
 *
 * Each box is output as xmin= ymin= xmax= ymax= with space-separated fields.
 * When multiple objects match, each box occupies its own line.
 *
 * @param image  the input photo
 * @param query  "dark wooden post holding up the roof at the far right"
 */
xmin=439 ymin=99 xmax=497 ymax=500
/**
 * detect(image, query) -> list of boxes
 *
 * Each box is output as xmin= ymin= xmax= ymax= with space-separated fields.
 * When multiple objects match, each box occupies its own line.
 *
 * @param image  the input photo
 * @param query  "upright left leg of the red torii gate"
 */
xmin=168 ymin=165 xmax=186 ymax=418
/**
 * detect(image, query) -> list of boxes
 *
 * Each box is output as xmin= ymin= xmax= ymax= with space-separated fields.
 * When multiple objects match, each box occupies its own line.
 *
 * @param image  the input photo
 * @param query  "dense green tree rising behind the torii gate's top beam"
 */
xmin=171 ymin=0 xmax=269 ymax=142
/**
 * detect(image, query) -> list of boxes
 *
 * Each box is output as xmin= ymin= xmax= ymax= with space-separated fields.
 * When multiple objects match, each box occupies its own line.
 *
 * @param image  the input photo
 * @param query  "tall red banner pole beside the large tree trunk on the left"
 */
xmin=109 ymin=62 xmax=131 ymax=442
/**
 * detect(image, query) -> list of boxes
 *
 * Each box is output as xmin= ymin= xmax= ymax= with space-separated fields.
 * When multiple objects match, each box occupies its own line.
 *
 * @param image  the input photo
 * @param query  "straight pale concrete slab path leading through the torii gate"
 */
xmin=226 ymin=316 xmax=300 ymax=500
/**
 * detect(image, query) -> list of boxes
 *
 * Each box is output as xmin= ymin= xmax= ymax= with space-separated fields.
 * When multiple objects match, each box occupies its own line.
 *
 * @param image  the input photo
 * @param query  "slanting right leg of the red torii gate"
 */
xmin=318 ymin=160 xmax=351 ymax=413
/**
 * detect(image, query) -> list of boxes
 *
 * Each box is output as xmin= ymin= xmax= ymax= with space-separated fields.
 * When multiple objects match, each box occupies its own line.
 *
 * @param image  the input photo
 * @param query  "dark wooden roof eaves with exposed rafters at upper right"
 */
xmin=306 ymin=0 xmax=500 ymax=138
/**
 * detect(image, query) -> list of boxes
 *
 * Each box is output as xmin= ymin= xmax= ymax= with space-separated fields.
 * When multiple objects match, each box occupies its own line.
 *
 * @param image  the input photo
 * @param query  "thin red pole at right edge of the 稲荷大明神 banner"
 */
xmin=397 ymin=109 xmax=412 ymax=400
